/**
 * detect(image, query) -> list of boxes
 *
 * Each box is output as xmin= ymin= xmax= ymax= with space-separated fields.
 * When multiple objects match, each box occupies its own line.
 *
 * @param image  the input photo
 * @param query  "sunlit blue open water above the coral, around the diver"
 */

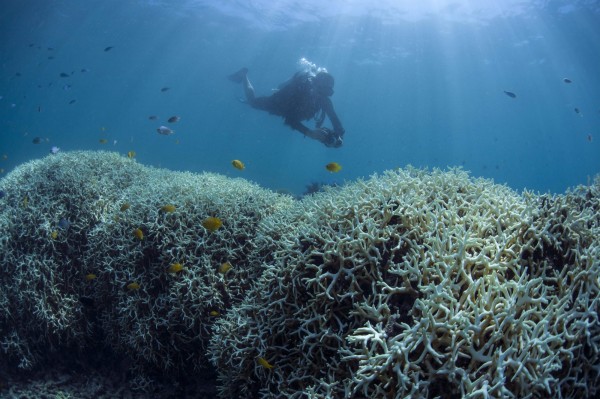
xmin=0 ymin=0 xmax=600 ymax=194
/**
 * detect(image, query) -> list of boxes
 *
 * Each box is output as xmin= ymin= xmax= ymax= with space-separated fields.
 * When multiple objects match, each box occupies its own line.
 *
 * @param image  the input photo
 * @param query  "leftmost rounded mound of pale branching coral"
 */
xmin=0 ymin=153 xmax=140 ymax=369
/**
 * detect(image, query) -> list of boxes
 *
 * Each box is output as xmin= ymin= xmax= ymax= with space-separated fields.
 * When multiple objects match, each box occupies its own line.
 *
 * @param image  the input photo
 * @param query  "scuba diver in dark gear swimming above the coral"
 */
xmin=228 ymin=68 xmax=344 ymax=148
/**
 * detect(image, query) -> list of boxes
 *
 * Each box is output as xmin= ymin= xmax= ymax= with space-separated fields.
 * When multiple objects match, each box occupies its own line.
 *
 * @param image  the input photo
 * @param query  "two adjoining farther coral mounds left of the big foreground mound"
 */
xmin=0 ymin=152 xmax=292 ymax=381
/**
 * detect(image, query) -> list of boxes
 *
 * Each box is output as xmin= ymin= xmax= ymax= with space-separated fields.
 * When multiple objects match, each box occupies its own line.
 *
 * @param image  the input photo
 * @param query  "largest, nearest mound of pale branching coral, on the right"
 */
xmin=210 ymin=169 xmax=600 ymax=398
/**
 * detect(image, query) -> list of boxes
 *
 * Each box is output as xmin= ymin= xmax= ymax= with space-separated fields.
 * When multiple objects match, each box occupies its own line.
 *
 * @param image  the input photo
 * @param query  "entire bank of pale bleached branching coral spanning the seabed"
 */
xmin=0 ymin=152 xmax=600 ymax=399
